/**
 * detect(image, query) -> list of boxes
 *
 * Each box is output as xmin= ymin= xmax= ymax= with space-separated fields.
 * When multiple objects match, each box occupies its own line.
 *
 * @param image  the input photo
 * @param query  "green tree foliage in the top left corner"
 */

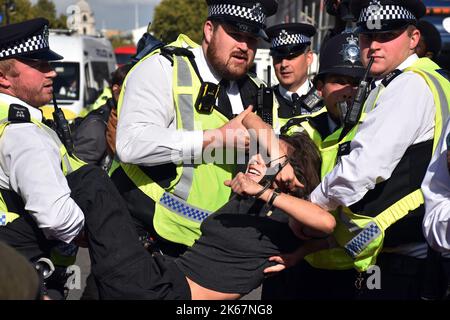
xmin=0 ymin=0 xmax=67 ymax=29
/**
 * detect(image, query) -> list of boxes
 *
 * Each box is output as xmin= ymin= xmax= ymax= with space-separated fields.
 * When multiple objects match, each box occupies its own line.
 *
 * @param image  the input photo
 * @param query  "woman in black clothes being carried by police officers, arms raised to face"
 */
xmin=86 ymin=110 xmax=335 ymax=299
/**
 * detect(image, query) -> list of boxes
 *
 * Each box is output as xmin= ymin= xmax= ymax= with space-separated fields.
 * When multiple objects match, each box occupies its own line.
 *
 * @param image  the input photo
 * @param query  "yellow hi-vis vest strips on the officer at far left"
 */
xmin=0 ymin=101 xmax=86 ymax=225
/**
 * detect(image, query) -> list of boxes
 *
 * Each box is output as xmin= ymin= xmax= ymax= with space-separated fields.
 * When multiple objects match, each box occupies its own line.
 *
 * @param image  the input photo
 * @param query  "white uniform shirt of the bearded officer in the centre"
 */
xmin=116 ymin=47 xmax=244 ymax=166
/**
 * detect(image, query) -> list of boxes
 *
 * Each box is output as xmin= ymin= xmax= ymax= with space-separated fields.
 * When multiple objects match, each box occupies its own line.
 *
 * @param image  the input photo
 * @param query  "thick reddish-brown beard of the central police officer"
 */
xmin=206 ymin=37 xmax=250 ymax=80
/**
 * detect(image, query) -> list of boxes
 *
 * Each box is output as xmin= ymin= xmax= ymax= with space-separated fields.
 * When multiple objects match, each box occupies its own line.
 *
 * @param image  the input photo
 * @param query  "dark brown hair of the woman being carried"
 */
xmin=280 ymin=132 xmax=322 ymax=198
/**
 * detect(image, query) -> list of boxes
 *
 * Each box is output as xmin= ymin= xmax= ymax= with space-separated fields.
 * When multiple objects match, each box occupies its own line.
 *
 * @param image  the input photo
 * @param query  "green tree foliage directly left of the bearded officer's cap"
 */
xmin=150 ymin=0 xmax=208 ymax=43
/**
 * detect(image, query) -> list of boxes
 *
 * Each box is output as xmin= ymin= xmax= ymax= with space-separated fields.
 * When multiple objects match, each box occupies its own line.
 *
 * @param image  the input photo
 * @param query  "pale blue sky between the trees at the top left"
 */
xmin=31 ymin=0 xmax=161 ymax=31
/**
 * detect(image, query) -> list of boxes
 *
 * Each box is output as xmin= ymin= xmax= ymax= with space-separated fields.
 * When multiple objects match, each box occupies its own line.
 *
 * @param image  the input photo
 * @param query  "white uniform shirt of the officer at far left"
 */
xmin=0 ymin=94 xmax=84 ymax=243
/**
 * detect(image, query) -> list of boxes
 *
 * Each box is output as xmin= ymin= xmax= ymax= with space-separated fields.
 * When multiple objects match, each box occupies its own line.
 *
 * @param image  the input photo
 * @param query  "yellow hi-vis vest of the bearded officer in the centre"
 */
xmin=119 ymin=35 xmax=264 ymax=246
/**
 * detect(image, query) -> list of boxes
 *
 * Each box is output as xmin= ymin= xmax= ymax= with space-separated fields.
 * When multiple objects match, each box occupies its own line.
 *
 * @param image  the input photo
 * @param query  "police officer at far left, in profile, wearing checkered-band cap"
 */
xmin=0 ymin=18 xmax=91 ymax=298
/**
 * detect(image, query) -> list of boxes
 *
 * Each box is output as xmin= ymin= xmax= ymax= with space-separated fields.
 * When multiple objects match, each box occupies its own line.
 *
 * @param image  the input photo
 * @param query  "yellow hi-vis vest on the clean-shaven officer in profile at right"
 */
xmin=305 ymin=58 xmax=450 ymax=272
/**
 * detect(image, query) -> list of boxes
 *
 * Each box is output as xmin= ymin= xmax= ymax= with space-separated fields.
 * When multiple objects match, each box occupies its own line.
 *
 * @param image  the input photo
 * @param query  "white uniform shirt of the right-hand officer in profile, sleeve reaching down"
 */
xmin=311 ymin=54 xmax=436 ymax=210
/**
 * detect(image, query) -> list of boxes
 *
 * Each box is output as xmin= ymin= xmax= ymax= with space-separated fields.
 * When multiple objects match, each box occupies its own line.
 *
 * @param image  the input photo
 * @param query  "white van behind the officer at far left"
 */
xmin=42 ymin=30 xmax=116 ymax=120
